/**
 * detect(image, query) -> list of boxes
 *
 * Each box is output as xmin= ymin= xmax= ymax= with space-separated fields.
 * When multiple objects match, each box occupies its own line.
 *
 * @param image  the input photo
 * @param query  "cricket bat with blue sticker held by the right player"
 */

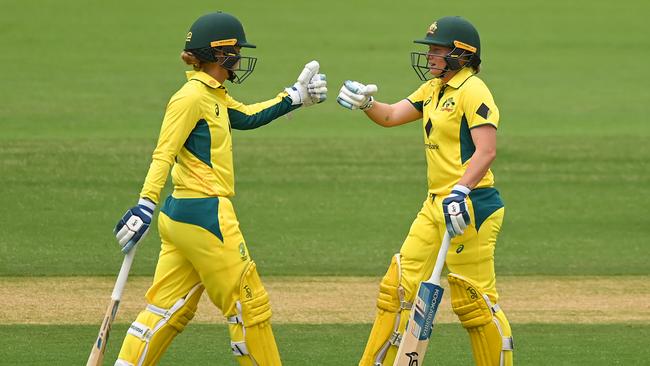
xmin=393 ymin=232 xmax=451 ymax=366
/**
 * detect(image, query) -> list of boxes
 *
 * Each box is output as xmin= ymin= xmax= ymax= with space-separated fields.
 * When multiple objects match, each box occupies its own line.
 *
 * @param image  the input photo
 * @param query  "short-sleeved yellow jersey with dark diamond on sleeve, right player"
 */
xmin=407 ymin=68 xmax=499 ymax=195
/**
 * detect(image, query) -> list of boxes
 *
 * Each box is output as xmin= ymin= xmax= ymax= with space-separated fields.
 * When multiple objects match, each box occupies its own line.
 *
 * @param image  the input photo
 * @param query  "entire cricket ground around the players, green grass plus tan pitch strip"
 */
xmin=0 ymin=0 xmax=650 ymax=366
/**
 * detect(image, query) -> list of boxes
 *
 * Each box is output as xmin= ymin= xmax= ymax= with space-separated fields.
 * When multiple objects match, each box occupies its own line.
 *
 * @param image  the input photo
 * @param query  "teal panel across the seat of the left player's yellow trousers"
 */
xmin=160 ymin=195 xmax=223 ymax=242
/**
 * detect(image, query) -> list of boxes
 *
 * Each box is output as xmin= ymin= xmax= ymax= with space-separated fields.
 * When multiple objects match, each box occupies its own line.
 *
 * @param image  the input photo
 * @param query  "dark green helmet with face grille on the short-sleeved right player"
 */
xmin=411 ymin=16 xmax=481 ymax=80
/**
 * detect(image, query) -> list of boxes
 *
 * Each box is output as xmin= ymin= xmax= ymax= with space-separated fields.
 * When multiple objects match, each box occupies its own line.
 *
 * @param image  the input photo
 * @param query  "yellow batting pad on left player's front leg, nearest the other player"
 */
xmin=228 ymin=261 xmax=281 ymax=366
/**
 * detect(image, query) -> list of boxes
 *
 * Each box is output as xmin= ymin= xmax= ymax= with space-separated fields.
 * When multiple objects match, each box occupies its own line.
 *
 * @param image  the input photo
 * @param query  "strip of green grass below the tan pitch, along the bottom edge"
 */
xmin=0 ymin=324 xmax=650 ymax=366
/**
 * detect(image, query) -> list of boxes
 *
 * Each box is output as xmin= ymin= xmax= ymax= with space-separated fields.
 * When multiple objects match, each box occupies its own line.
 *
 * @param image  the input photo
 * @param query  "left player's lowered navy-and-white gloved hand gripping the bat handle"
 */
xmin=113 ymin=198 xmax=156 ymax=254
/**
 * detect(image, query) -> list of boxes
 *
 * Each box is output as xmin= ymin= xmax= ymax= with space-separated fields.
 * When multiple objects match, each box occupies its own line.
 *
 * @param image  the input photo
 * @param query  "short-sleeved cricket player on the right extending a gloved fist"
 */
xmin=337 ymin=16 xmax=513 ymax=366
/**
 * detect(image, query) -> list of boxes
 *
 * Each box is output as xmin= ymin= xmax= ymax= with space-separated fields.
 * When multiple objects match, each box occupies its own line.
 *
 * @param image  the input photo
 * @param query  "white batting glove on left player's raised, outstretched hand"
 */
xmin=284 ymin=61 xmax=327 ymax=107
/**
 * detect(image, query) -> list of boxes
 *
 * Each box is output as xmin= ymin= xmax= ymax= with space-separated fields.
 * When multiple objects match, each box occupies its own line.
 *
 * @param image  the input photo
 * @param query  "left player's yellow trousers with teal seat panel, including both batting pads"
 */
xmin=116 ymin=196 xmax=280 ymax=365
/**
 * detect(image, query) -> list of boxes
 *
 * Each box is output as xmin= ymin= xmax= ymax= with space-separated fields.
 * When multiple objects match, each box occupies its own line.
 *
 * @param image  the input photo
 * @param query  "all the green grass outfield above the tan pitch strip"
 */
xmin=0 ymin=0 xmax=650 ymax=276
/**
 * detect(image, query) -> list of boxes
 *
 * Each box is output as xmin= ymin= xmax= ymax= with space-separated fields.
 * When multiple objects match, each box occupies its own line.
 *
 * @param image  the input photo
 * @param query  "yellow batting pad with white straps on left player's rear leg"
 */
xmin=116 ymin=284 xmax=204 ymax=366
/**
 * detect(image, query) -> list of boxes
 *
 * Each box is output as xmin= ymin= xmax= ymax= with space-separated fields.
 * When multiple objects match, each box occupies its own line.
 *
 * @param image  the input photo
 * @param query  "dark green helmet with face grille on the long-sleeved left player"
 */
xmin=184 ymin=12 xmax=257 ymax=83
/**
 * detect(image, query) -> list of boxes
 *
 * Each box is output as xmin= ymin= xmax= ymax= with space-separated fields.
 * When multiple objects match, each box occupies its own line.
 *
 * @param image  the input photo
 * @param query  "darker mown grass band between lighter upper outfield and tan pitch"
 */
xmin=0 ymin=136 xmax=650 ymax=276
